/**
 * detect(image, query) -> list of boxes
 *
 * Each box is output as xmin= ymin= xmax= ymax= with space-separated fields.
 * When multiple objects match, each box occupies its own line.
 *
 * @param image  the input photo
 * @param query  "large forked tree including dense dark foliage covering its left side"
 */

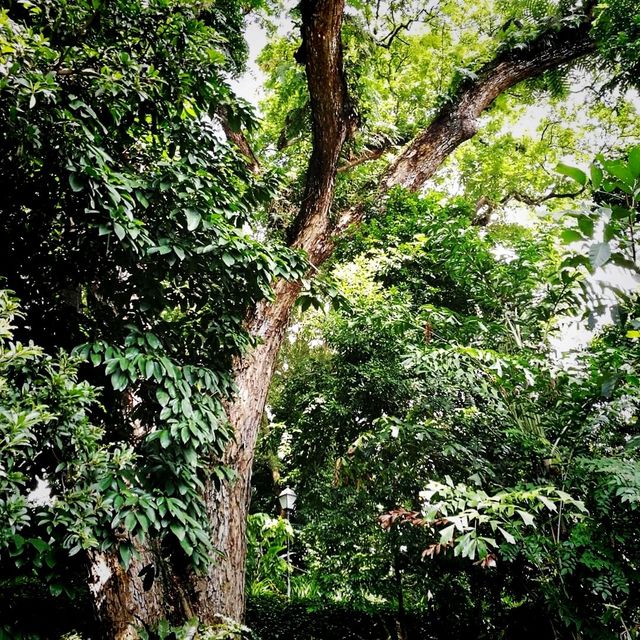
xmin=0 ymin=0 xmax=637 ymax=638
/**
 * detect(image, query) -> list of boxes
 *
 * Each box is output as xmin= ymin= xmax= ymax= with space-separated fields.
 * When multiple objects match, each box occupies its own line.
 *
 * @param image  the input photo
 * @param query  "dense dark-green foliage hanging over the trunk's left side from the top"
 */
xmin=0 ymin=0 xmax=305 ymax=567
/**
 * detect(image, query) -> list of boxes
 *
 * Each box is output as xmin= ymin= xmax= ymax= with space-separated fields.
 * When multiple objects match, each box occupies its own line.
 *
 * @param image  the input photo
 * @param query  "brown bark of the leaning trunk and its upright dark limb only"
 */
xmin=192 ymin=0 xmax=356 ymax=621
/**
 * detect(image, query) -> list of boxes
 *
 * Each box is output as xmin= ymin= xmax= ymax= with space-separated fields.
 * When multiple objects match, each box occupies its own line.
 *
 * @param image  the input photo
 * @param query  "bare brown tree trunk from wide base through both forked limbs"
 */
xmin=92 ymin=0 xmax=593 ymax=640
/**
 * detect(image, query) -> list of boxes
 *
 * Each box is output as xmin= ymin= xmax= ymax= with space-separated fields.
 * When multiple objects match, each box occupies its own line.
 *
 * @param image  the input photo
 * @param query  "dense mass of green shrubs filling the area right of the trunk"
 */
xmin=255 ymin=184 xmax=640 ymax=638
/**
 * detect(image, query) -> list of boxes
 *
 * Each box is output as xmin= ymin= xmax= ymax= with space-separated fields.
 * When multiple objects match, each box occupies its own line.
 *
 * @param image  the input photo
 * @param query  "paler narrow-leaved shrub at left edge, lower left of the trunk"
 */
xmin=0 ymin=291 xmax=140 ymax=596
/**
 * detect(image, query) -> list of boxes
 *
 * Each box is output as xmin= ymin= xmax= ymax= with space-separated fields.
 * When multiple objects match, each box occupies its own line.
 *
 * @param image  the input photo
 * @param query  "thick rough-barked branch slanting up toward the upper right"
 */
xmin=380 ymin=21 xmax=595 ymax=192
